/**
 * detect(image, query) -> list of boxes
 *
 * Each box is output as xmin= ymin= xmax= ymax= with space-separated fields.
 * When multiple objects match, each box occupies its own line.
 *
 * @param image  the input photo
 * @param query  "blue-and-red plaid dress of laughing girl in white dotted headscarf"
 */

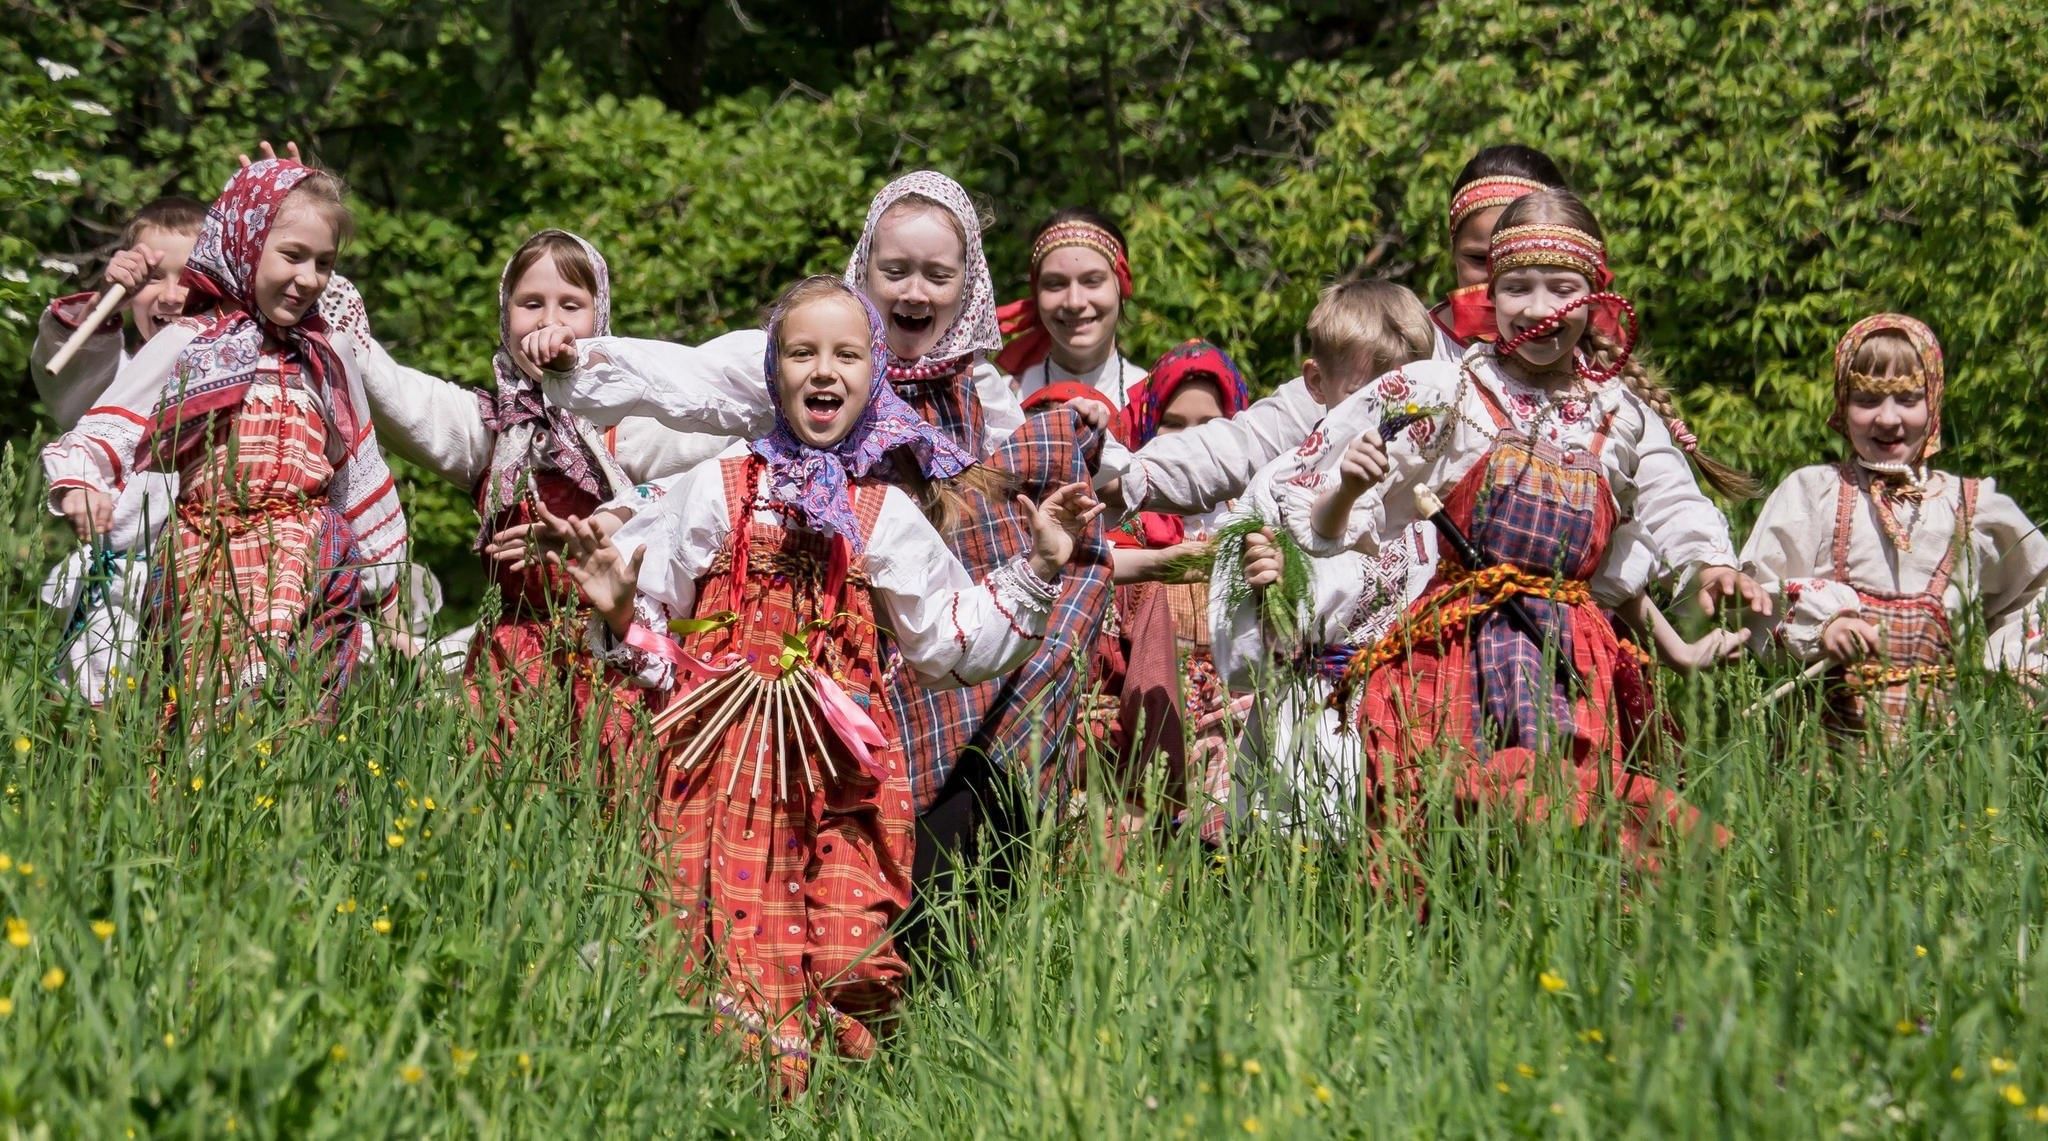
xmin=891 ymin=373 xmax=1112 ymax=811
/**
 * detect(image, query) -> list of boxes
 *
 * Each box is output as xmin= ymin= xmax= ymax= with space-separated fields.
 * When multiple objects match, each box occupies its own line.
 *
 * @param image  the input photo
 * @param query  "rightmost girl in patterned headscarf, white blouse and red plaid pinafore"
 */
xmin=1743 ymin=313 xmax=2048 ymax=737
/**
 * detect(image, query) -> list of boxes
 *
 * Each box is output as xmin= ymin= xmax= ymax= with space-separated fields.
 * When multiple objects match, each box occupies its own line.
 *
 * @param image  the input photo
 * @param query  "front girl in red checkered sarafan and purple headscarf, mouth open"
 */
xmin=536 ymin=277 xmax=1102 ymax=1094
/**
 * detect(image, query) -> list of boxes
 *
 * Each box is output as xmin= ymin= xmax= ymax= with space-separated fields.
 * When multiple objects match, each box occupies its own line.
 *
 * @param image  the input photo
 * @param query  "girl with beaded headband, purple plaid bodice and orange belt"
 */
xmin=1280 ymin=191 xmax=1769 ymax=875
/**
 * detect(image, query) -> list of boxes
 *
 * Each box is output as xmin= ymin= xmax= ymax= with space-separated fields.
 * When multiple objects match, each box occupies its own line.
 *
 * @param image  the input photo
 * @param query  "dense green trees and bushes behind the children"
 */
xmin=0 ymin=0 xmax=2048 ymax=589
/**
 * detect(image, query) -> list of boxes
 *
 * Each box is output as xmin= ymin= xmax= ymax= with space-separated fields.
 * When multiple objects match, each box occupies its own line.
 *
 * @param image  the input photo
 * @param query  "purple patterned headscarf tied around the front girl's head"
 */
xmin=748 ymin=279 xmax=975 ymax=555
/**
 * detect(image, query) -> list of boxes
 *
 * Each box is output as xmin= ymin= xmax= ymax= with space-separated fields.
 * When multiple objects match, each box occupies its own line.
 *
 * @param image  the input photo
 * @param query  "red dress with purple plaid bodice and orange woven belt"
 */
xmin=1360 ymin=389 xmax=1698 ymax=864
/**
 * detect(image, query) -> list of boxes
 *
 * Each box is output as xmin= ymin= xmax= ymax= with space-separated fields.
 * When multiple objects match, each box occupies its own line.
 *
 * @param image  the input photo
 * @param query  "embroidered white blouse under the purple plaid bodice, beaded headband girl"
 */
xmin=1280 ymin=348 xmax=1737 ymax=606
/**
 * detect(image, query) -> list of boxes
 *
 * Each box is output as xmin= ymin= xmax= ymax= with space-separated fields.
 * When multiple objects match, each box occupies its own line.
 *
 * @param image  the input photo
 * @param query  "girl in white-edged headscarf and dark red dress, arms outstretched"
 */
xmin=362 ymin=229 xmax=731 ymax=785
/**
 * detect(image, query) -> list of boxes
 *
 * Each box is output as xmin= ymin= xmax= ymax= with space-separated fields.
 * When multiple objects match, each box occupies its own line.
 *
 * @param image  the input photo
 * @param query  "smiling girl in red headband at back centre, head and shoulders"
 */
xmin=995 ymin=207 xmax=1145 ymax=408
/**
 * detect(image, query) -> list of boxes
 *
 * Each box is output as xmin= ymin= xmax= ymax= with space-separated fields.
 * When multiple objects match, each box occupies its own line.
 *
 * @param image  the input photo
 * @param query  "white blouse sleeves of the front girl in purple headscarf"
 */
xmin=590 ymin=445 xmax=1059 ymax=688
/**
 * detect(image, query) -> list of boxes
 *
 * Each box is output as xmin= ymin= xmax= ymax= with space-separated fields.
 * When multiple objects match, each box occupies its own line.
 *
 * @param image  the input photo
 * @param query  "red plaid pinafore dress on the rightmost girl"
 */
xmin=1825 ymin=465 xmax=1976 ymax=737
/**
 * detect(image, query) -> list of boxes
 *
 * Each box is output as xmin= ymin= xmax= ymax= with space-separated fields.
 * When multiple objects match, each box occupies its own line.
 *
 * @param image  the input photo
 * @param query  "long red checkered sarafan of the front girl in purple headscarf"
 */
xmin=649 ymin=457 xmax=913 ymax=1094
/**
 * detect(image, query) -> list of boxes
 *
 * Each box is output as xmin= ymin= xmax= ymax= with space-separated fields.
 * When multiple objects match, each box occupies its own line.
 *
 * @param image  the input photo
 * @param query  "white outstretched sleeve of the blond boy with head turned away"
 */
xmin=1122 ymin=377 xmax=1323 ymax=514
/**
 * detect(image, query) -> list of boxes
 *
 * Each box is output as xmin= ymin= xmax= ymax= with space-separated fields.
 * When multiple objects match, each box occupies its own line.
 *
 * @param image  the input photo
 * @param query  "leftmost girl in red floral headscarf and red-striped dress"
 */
xmin=43 ymin=160 xmax=406 ymax=713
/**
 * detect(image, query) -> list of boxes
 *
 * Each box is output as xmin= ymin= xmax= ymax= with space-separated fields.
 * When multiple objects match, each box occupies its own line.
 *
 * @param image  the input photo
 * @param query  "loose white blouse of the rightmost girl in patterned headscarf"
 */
xmin=1743 ymin=463 xmax=2048 ymax=670
